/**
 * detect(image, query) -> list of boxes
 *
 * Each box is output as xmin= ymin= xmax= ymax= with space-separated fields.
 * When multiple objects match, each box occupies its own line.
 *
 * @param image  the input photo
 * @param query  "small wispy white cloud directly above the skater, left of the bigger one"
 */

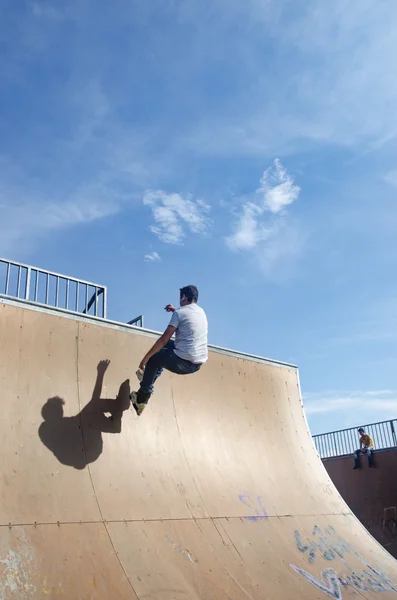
xmin=143 ymin=190 xmax=210 ymax=244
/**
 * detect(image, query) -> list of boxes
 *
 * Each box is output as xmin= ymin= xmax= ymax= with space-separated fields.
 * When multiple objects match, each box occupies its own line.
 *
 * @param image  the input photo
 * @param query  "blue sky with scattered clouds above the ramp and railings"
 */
xmin=0 ymin=0 xmax=397 ymax=433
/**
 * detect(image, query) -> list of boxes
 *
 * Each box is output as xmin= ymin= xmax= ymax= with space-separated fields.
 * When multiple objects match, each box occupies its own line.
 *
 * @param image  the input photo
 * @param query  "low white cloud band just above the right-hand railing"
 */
xmin=303 ymin=390 xmax=397 ymax=420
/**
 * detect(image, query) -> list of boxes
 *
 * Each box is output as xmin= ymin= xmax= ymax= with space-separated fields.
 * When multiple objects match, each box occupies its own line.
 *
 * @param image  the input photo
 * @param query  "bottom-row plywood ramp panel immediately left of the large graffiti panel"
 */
xmin=109 ymin=520 xmax=254 ymax=600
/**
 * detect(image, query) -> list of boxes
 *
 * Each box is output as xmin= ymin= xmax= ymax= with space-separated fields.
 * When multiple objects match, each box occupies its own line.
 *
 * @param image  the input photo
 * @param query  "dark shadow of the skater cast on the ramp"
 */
xmin=38 ymin=360 xmax=130 ymax=469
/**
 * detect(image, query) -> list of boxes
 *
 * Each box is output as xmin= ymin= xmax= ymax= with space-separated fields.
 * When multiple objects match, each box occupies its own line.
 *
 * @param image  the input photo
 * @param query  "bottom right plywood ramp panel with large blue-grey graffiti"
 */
xmin=215 ymin=515 xmax=397 ymax=600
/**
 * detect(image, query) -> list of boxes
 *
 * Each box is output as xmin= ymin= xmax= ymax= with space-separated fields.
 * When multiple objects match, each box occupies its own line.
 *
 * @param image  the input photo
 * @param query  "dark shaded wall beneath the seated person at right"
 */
xmin=323 ymin=448 xmax=397 ymax=558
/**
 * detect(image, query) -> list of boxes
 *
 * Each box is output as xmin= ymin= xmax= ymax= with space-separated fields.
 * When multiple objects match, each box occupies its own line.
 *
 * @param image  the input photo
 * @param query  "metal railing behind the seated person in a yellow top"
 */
xmin=313 ymin=419 xmax=397 ymax=458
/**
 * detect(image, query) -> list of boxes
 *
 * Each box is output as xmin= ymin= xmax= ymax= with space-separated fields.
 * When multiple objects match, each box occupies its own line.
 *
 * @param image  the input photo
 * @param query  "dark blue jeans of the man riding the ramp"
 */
xmin=137 ymin=340 xmax=201 ymax=403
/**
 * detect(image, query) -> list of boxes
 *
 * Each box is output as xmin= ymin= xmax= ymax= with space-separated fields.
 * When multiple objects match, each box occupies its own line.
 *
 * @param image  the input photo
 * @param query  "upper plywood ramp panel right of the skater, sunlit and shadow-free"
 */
xmin=172 ymin=354 xmax=347 ymax=517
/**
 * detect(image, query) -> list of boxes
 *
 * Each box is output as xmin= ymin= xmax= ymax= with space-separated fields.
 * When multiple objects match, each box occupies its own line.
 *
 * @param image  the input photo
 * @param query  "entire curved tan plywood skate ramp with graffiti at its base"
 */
xmin=0 ymin=299 xmax=397 ymax=600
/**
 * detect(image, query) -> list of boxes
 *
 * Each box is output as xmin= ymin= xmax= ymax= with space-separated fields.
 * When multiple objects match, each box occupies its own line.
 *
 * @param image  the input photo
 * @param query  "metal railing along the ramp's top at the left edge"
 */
xmin=0 ymin=258 xmax=107 ymax=319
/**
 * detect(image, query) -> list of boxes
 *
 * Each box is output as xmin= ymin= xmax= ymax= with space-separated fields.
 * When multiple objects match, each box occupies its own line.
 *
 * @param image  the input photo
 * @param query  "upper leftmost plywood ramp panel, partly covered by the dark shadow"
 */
xmin=0 ymin=305 xmax=99 ymax=524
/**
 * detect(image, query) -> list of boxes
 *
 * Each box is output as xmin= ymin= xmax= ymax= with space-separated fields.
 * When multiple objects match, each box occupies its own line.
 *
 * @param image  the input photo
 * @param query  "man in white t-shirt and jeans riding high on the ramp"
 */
xmin=130 ymin=285 xmax=208 ymax=416
